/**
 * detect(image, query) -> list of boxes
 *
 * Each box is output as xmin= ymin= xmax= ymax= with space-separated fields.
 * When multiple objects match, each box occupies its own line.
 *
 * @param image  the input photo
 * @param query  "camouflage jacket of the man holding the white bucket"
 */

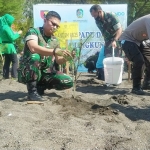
xmin=96 ymin=12 xmax=121 ymax=42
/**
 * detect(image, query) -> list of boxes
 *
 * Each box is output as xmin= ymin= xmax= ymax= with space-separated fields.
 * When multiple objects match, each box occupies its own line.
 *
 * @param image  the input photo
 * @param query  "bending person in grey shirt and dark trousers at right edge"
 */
xmin=120 ymin=15 xmax=150 ymax=95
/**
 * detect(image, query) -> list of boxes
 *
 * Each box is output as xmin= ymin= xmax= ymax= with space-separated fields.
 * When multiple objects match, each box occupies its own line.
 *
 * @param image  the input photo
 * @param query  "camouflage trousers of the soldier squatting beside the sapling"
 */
xmin=18 ymin=54 xmax=73 ymax=90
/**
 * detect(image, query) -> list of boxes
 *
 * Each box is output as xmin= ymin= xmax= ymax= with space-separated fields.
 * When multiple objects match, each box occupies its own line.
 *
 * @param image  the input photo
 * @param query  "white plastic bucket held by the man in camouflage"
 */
xmin=103 ymin=57 xmax=124 ymax=84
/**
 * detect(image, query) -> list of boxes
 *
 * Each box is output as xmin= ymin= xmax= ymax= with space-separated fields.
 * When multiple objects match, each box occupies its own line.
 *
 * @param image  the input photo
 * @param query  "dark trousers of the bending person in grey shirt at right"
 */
xmin=122 ymin=41 xmax=150 ymax=88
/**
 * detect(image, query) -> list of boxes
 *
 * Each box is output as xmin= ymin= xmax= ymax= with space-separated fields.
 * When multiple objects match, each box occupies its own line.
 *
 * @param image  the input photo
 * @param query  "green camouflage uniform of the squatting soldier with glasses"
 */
xmin=18 ymin=27 xmax=73 ymax=94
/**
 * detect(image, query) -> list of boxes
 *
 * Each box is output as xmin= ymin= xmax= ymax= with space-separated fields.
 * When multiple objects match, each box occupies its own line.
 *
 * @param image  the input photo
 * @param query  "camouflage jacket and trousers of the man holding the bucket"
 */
xmin=96 ymin=12 xmax=121 ymax=56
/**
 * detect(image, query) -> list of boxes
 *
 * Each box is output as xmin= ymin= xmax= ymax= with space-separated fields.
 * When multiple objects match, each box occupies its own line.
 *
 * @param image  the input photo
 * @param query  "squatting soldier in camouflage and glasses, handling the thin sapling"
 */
xmin=18 ymin=11 xmax=73 ymax=100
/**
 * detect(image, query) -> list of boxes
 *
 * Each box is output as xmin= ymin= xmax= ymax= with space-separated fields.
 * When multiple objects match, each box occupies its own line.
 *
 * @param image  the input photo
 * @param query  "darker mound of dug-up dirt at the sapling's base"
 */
xmin=54 ymin=97 xmax=119 ymax=117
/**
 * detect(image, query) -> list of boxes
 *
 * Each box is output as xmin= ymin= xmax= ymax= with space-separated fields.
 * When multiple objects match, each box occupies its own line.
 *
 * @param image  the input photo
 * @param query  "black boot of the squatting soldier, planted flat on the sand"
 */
xmin=27 ymin=81 xmax=44 ymax=101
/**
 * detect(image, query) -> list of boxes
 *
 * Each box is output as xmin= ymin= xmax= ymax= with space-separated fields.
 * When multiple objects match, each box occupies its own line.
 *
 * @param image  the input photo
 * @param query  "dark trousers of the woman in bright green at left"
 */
xmin=3 ymin=54 xmax=18 ymax=79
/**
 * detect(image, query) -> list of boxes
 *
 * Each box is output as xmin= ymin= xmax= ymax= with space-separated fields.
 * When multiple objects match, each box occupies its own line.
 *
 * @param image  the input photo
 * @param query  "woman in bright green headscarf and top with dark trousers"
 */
xmin=0 ymin=14 xmax=22 ymax=79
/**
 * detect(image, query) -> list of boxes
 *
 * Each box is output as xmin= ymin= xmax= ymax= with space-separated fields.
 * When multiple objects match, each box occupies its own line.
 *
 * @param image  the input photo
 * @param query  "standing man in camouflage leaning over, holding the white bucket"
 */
xmin=90 ymin=5 xmax=122 ymax=57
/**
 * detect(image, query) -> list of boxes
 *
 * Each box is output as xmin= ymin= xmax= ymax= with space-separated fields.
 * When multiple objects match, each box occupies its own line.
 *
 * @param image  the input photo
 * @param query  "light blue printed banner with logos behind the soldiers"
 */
xmin=33 ymin=4 xmax=127 ymax=71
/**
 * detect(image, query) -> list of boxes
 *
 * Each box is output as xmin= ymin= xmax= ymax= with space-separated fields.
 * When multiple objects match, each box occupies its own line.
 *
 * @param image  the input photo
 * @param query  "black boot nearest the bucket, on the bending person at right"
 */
xmin=131 ymin=79 xmax=145 ymax=95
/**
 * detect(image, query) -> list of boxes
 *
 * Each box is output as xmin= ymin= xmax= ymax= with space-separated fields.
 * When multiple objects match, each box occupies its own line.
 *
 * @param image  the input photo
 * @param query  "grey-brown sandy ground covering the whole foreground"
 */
xmin=0 ymin=74 xmax=150 ymax=150
